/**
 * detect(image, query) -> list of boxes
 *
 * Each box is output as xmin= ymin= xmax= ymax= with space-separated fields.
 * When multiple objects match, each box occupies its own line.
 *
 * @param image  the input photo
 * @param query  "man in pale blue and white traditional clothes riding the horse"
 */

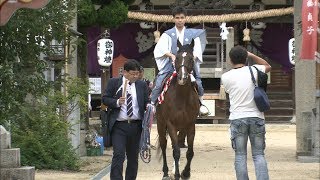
xmin=151 ymin=7 xmax=209 ymax=116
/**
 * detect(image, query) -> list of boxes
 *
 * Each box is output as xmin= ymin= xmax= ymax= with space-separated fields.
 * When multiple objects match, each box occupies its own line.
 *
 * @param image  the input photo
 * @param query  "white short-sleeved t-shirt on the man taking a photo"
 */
xmin=221 ymin=65 xmax=266 ymax=120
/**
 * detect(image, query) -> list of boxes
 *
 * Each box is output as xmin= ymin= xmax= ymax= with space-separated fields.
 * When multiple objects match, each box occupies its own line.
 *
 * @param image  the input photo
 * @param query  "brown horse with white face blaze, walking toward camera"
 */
xmin=156 ymin=40 xmax=199 ymax=179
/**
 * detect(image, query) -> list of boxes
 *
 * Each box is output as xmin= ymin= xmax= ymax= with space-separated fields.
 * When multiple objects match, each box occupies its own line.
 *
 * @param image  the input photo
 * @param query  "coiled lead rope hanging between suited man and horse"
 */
xmin=140 ymin=106 xmax=154 ymax=163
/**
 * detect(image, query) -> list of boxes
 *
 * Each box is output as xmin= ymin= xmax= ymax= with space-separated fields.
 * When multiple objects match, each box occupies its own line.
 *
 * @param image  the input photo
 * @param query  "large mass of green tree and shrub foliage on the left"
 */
xmin=0 ymin=0 xmax=88 ymax=169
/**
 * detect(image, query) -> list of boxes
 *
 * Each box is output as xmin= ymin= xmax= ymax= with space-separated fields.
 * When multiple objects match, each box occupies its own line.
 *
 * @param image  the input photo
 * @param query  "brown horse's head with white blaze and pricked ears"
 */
xmin=175 ymin=39 xmax=194 ymax=85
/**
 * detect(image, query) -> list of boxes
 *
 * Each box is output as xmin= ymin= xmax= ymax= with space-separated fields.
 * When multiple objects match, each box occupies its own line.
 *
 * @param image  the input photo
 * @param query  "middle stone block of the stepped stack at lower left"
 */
xmin=0 ymin=148 xmax=20 ymax=168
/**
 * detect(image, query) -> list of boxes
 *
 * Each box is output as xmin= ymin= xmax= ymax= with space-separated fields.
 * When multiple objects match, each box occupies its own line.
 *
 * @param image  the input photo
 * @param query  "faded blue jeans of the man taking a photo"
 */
xmin=230 ymin=117 xmax=269 ymax=180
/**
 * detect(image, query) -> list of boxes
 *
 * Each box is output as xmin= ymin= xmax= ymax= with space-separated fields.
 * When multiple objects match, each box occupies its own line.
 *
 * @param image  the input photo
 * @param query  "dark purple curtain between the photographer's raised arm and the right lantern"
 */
xmin=251 ymin=23 xmax=293 ymax=72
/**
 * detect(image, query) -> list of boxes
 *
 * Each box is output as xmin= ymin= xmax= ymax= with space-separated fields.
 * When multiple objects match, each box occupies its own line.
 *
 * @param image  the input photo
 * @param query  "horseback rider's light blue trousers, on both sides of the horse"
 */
xmin=151 ymin=60 xmax=204 ymax=104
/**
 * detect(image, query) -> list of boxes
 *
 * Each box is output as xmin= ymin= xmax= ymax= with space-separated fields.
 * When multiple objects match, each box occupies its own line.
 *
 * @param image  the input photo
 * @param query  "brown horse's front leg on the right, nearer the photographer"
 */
xmin=181 ymin=126 xmax=195 ymax=179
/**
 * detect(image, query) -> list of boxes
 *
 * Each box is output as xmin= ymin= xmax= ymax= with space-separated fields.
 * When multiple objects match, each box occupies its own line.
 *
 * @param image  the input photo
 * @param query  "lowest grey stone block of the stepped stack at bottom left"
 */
xmin=0 ymin=166 xmax=35 ymax=180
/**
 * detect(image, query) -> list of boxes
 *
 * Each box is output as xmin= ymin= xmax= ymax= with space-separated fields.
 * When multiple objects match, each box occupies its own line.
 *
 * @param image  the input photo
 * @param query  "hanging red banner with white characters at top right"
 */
xmin=300 ymin=0 xmax=319 ymax=60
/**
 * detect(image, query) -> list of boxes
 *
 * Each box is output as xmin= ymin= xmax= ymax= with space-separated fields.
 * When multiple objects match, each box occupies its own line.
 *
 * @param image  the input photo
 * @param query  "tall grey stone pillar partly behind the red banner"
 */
xmin=294 ymin=0 xmax=316 ymax=156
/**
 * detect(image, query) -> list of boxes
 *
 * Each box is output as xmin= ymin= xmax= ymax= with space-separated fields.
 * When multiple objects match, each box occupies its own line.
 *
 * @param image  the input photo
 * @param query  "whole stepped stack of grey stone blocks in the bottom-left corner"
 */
xmin=0 ymin=125 xmax=35 ymax=180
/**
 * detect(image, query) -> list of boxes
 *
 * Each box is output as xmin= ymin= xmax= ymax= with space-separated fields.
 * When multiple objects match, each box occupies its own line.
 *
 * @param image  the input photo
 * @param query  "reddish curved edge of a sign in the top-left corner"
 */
xmin=0 ymin=0 xmax=50 ymax=26
